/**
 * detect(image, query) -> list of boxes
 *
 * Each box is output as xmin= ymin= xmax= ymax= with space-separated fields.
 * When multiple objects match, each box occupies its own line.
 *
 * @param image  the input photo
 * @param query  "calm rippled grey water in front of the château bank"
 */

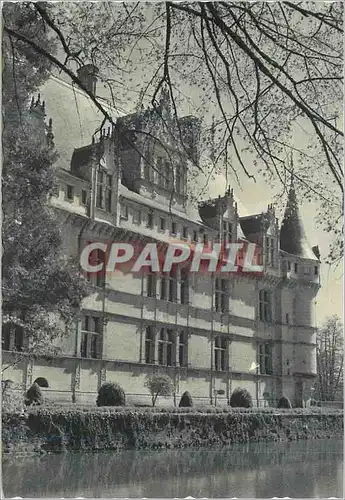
xmin=3 ymin=439 xmax=343 ymax=498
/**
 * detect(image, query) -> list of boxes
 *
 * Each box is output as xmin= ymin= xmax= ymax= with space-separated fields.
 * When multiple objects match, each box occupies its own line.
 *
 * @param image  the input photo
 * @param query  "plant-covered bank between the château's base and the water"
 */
xmin=2 ymin=407 xmax=343 ymax=453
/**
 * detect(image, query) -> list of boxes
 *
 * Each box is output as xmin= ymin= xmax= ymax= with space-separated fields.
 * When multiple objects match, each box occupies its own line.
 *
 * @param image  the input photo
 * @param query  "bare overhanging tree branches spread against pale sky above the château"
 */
xmin=4 ymin=2 xmax=343 ymax=261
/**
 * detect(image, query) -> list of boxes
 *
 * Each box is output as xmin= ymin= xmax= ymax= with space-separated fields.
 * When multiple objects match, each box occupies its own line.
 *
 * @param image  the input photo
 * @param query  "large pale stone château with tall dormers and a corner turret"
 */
xmin=3 ymin=66 xmax=320 ymax=406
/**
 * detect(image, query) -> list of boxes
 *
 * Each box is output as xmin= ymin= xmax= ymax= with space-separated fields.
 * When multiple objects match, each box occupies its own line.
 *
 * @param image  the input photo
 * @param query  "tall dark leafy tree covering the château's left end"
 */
xmin=2 ymin=3 xmax=88 ymax=369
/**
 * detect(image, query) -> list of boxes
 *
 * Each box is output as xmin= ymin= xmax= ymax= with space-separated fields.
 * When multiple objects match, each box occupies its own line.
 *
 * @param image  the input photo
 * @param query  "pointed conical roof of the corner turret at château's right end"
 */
xmin=280 ymin=181 xmax=318 ymax=260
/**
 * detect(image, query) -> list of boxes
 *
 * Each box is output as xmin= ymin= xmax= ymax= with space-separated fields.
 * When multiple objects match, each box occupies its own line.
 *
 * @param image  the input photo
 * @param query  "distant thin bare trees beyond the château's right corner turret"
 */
xmin=313 ymin=315 xmax=344 ymax=401
